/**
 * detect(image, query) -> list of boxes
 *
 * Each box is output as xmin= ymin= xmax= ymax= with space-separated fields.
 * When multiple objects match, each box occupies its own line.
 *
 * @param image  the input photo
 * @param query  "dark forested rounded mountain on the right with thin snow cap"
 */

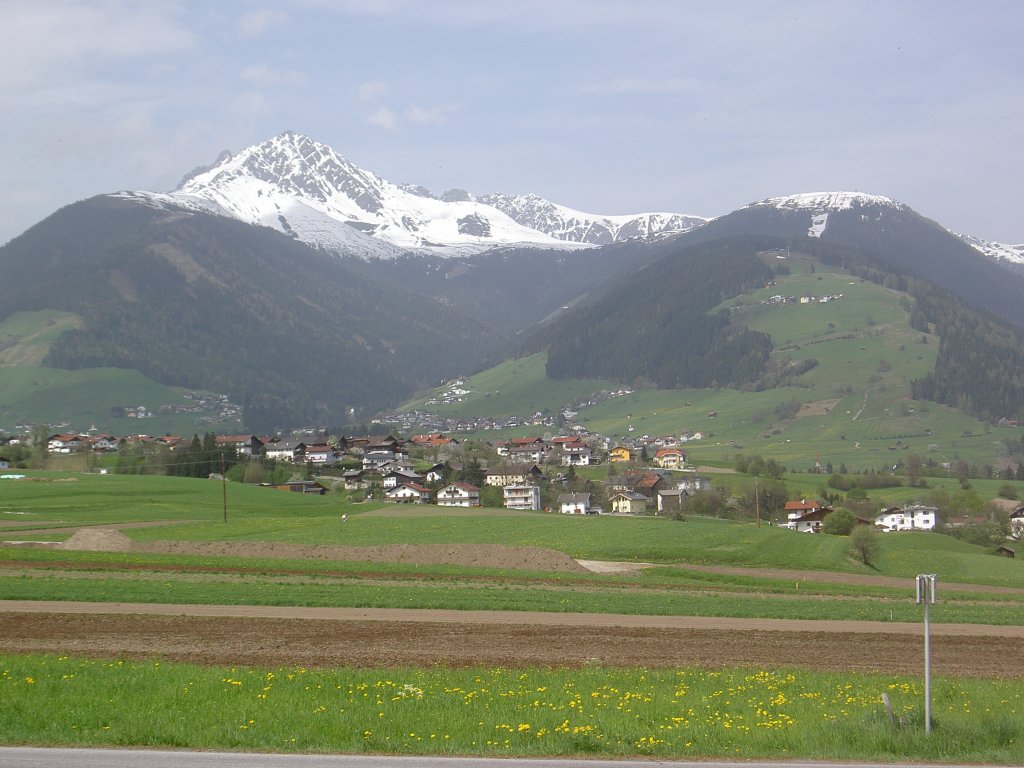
xmin=526 ymin=194 xmax=1024 ymax=422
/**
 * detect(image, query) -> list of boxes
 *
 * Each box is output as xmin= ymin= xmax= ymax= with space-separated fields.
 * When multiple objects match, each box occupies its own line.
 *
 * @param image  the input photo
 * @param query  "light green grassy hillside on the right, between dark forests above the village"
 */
xmin=401 ymin=261 xmax=1016 ymax=470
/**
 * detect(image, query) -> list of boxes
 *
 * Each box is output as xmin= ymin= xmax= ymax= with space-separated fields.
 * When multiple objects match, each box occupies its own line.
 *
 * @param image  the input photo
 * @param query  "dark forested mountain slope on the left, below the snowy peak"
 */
xmin=0 ymin=197 xmax=506 ymax=429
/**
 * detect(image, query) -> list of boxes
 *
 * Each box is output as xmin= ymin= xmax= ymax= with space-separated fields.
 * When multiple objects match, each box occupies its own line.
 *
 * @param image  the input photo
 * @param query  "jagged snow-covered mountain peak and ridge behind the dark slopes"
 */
xmin=112 ymin=131 xmax=705 ymax=257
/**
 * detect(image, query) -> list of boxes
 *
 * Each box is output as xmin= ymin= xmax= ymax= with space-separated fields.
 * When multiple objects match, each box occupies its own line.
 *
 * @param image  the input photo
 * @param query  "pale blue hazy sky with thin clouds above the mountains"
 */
xmin=0 ymin=0 xmax=1024 ymax=244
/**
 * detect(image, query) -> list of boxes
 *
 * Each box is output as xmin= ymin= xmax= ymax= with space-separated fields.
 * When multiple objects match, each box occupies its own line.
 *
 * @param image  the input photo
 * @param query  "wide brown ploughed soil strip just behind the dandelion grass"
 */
xmin=0 ymin=601 xmax=1024 ymax=678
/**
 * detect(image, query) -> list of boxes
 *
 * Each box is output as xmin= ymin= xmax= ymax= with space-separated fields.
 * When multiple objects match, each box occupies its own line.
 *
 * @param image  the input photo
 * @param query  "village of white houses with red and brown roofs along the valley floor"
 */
xmin=0 ymin=423 xmax=1024 ymax=551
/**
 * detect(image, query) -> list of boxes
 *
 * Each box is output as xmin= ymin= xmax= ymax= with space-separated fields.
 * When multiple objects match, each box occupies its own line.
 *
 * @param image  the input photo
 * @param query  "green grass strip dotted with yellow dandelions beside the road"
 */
xmin=0 ymin=655 xmax=1024 ymax=765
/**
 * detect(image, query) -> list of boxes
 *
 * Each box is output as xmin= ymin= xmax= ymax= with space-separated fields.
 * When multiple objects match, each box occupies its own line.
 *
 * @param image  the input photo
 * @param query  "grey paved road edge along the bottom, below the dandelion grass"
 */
xmin=0 ymin=746 xmax=982 ymax=768
